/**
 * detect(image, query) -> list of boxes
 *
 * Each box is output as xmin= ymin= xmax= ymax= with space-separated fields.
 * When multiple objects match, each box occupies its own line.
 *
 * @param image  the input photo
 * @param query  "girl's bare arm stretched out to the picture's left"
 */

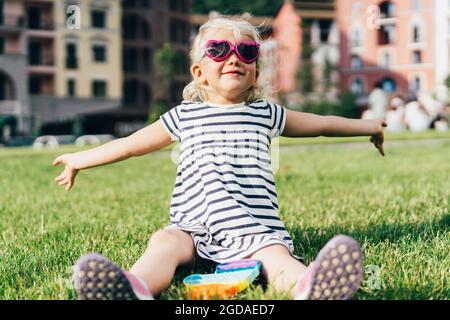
xmin=52 ymin=120 xmax=173 ymax=191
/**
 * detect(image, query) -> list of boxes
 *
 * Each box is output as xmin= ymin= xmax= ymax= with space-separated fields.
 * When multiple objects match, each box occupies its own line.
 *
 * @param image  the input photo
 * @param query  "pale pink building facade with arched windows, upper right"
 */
xmin=336 ymin=0 xmax=437 ymax=102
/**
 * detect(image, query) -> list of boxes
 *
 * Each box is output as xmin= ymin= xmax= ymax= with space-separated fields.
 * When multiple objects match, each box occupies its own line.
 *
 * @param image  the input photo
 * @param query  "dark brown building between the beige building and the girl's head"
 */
xmin=122 ymin=0 xmax=191 ymax=114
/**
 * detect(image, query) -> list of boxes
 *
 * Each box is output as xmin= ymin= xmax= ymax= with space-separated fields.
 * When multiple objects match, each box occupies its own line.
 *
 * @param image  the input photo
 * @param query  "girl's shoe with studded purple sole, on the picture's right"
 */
xmin=296 ymin=235 xmax=364 ymax=300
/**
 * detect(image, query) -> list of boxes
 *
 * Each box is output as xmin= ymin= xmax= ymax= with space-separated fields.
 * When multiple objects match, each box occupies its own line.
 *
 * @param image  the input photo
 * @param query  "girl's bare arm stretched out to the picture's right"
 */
xmin=283 ymin=109 xmax=387 ymax=156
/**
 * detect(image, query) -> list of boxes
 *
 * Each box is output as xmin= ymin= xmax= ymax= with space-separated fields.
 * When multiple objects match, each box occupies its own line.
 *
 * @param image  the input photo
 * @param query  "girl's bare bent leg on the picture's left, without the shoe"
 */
xmin=130 ymin=229 xmax=195 ymax=296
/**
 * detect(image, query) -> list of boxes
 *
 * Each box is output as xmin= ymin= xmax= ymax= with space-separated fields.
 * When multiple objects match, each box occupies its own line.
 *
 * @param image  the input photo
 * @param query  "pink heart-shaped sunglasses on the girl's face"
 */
xmin=205 ymin=40 xmax=259 ymax=63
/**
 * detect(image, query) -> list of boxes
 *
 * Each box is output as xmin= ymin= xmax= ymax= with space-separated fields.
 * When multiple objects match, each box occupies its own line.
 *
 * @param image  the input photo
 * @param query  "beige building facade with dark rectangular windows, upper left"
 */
xmin=54 ymin=0 xmax=123 ymax=99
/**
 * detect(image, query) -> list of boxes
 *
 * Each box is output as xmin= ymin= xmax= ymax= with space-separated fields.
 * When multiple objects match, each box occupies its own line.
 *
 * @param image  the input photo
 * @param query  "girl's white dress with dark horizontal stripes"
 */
xmin=161 ymin=100 xmax=296 ymax=263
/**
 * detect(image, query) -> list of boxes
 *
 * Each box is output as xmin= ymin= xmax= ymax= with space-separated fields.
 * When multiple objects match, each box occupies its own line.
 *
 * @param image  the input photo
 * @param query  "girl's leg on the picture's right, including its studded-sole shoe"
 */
xmin=251 ymin=235 xmax=364 ymax=300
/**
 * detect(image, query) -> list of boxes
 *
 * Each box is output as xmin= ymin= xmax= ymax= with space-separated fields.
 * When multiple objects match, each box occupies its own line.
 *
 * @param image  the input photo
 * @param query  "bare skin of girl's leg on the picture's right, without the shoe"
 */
xmin=251 ymin=245 xmax=306 ymax=297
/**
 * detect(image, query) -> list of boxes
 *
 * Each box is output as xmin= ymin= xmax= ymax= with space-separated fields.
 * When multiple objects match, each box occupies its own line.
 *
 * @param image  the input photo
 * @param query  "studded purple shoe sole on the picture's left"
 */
xmin=74 ymin=253 xmax=138 ymax=300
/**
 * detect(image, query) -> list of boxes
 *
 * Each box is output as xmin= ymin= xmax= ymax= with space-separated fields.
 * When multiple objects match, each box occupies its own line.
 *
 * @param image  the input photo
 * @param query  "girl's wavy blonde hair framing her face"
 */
xmin=183 ymin=16 xmax=273 ymax=103
